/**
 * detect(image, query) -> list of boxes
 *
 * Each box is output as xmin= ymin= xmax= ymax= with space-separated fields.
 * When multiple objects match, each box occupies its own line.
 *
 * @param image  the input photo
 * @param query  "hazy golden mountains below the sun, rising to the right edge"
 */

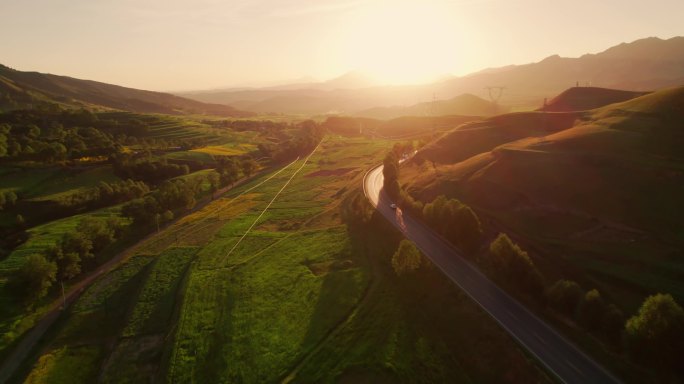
xmin=180 ymin=37 xmax=684 ymax=115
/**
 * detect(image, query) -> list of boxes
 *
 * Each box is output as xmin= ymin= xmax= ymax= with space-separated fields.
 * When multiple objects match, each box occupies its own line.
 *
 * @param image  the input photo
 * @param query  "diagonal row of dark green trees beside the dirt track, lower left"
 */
xmin=10 ymin=217 xmax=124 ymax=303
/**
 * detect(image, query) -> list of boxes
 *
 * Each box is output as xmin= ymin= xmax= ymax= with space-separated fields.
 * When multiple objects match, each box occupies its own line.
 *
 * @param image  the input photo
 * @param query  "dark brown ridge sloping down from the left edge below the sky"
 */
xmin=0 ymin=65 xmax=251 ymax=117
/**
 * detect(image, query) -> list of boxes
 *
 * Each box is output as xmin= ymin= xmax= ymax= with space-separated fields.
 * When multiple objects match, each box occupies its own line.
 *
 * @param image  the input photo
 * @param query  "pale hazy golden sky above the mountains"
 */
xmin=0 ymin=0 xmax=684 ymax=90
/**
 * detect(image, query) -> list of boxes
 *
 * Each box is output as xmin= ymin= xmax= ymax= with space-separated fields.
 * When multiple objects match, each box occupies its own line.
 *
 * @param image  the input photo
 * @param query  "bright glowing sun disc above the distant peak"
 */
xmin=345 ymin=1 xmax=460 ymax=84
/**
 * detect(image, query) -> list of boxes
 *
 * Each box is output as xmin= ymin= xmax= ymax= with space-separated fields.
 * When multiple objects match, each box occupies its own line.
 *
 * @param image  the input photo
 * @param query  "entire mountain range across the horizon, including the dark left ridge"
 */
xmin=0 ymin=37 xmax=684 ymax=119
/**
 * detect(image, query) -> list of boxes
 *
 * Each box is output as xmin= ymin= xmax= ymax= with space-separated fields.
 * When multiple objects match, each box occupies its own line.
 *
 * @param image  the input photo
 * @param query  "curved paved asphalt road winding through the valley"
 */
xmin=363 ymin=166 xmax=620 ymax=384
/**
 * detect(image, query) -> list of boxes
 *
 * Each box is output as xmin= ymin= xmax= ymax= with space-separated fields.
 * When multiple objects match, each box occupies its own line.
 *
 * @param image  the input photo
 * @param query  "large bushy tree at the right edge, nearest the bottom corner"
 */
xmin=625 ymin=293 xmax=684 ymax=368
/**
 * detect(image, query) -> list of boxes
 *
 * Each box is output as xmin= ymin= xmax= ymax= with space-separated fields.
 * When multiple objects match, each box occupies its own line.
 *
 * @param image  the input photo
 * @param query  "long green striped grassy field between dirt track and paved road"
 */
xmin=14 ymin=137 xmax=546 ymax=383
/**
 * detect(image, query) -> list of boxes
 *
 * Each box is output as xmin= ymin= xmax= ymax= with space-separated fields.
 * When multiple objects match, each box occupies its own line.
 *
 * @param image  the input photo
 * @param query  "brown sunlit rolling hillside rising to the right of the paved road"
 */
xmin=401 ymin=87 xmax=684 ymax=310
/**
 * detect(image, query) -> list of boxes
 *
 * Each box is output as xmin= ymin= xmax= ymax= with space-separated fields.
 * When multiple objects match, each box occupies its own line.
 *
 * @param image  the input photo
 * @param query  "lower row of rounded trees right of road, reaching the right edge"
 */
xmin=492 ymin=234 xmax=684 ymax=373
